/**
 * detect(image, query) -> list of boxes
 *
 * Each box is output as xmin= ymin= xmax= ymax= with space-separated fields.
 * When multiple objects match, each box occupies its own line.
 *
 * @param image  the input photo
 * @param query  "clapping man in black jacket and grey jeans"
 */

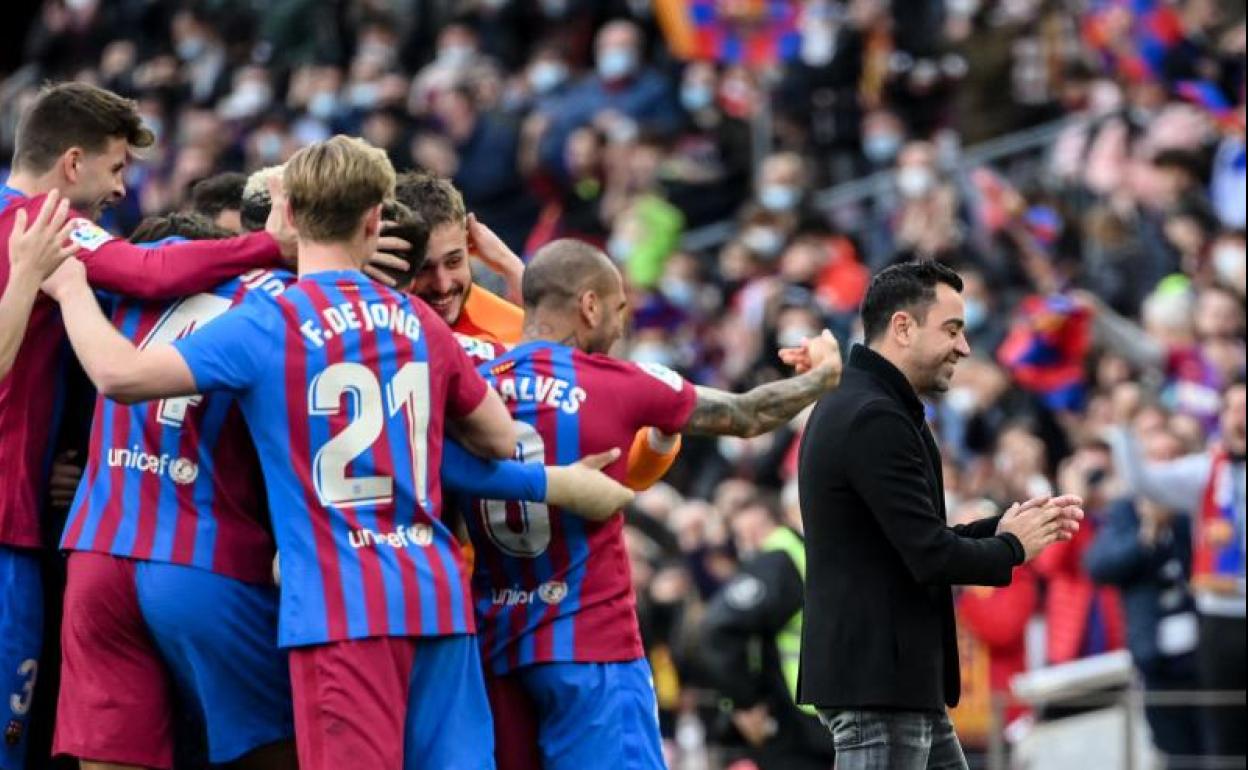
xmin=799 ymin=262 xmax=1083 ymax=770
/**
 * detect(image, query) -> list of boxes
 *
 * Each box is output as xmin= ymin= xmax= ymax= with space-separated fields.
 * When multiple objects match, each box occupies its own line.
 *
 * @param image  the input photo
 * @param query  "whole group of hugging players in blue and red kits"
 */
xmin=0 ymin=84 xmax=841 ymax=770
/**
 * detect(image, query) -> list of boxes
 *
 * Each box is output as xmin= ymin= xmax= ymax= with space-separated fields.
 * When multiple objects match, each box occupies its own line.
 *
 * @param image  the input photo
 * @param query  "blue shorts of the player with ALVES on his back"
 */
xmin=513 ymin=659 xmax=666 ymax=770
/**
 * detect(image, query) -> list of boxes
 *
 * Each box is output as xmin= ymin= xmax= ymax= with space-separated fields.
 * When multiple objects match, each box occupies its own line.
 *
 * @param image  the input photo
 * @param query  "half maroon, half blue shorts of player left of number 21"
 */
xmin=55 ymin=552 xmax=295 ymax=768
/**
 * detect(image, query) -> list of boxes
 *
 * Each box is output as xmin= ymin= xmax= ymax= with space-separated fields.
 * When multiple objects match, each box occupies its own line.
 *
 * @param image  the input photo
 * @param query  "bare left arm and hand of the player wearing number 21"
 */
xmin=44 ymin=260 xmax=196 ymax=403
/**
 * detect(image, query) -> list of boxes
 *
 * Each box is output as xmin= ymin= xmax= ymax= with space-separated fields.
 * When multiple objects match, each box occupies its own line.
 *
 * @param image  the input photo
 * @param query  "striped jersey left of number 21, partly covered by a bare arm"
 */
xmin=61 ymin=270 xmax=295 ymax=583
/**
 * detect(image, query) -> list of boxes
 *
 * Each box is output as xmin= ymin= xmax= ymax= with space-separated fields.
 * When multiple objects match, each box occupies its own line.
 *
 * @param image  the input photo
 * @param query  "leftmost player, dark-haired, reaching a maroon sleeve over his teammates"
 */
xmin=0 ymin=82 xmax=293 ymax=770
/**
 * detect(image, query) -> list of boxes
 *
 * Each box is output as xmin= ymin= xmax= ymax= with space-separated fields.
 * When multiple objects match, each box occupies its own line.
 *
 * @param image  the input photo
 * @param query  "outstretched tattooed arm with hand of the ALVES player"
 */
xmin=683 ymin=331 xmax=841 ymax=438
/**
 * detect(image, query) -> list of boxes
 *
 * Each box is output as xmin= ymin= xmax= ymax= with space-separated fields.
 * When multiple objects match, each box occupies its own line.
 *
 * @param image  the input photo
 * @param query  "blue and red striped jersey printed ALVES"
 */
xmin=464 ymin=341 xmax=696 ymax=674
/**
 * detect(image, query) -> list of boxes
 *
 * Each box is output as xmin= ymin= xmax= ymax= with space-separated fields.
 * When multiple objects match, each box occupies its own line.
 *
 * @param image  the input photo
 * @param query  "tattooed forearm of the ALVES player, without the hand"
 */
xmin=684 ymin=368 xmax=834 ymax=438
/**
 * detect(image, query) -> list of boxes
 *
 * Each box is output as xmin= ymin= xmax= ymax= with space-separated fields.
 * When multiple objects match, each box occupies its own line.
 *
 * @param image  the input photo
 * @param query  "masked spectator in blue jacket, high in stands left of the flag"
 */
xmin=531 ymin=20 xmax=680 ymax=178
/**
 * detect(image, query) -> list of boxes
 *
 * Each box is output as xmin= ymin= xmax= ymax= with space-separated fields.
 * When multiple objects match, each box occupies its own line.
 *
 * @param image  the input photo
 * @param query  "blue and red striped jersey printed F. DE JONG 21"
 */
xmin=173 ymin=271 xmax=487 ymax=646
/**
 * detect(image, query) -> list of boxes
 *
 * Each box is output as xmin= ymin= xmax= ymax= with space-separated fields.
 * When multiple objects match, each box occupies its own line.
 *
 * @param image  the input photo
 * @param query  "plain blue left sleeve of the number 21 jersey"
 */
xmin=173 ymin=295 xmax=283 ymax=392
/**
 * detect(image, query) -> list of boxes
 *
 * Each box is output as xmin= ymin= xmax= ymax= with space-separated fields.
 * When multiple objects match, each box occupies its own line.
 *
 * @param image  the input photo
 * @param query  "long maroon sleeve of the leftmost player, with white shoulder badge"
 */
xmin=70 ymin=207 xmax=282 ymax=300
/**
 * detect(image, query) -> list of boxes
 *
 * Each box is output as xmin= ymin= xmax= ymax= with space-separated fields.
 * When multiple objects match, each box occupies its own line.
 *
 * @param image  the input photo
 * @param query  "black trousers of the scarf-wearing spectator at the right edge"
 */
xmin=1196 ymin=615 xmax=1248 ymax=758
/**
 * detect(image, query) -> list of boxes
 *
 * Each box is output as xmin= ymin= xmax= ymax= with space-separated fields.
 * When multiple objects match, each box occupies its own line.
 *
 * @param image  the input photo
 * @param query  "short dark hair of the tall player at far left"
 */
xmin=12 ymin=82 xmax=156 ymax=173
